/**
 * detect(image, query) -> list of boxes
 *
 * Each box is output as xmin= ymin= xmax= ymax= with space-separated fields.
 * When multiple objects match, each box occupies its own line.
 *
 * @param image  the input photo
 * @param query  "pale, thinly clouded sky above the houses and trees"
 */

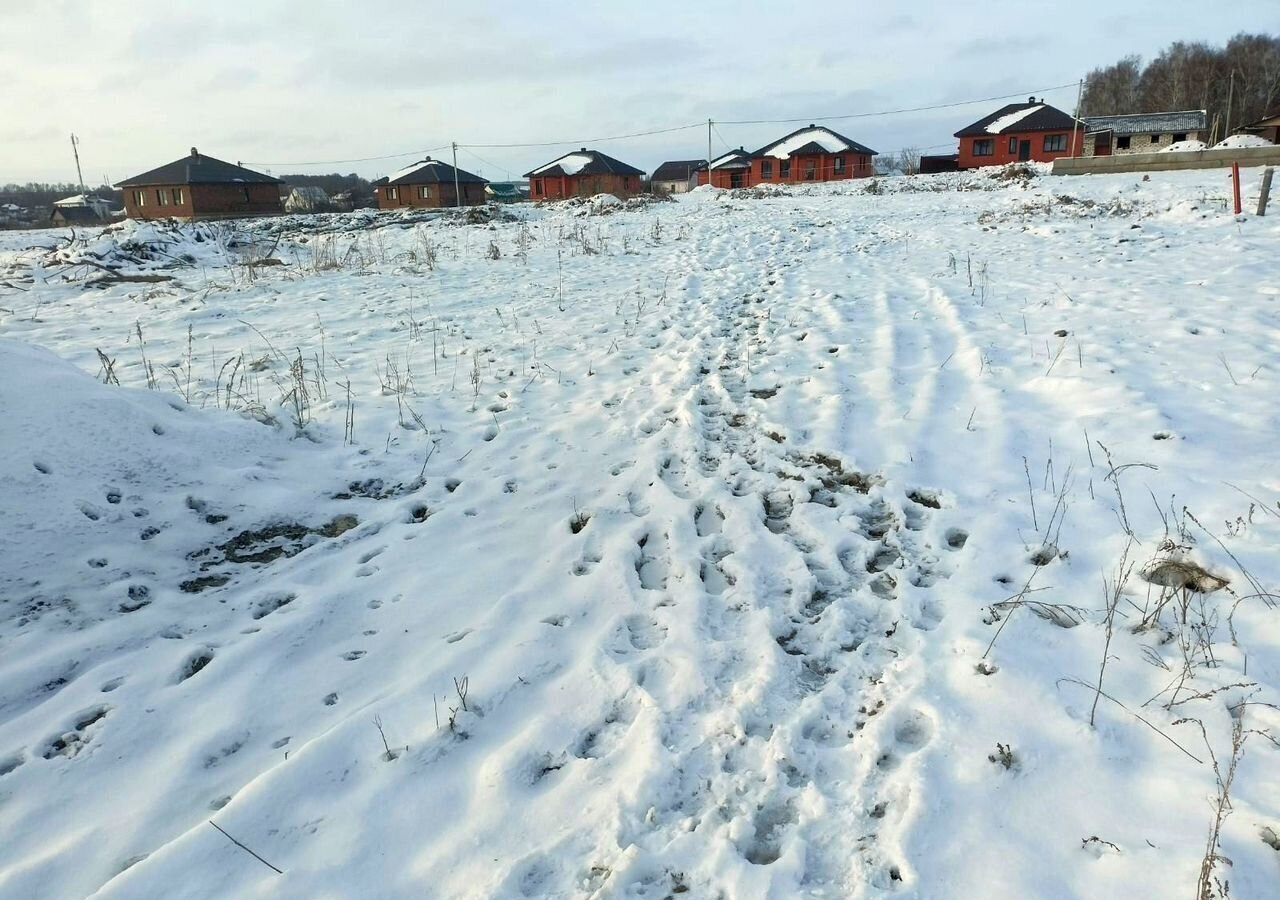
xmin=0 ymin=0 xmax=1280 ymax=183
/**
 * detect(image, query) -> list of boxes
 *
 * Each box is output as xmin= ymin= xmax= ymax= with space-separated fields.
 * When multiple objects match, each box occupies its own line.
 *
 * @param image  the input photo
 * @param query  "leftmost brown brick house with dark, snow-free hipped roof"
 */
xmin=116 ymin=147 xmax=282 ymax=221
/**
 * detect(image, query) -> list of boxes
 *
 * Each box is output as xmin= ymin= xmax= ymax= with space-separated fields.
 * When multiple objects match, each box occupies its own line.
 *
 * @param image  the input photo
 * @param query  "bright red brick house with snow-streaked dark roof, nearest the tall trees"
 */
xmin=955 ymin=97 xmax=1085 ymax=169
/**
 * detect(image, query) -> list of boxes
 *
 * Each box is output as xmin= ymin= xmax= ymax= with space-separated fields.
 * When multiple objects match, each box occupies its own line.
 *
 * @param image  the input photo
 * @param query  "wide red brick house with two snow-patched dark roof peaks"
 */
xmin=698 ymin=124 xmax=876 ymax=187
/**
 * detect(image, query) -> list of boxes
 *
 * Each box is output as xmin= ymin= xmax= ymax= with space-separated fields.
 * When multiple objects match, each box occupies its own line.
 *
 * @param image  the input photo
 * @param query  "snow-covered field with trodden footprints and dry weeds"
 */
xmin=0 ymin=170 xmax=1280 ymax=900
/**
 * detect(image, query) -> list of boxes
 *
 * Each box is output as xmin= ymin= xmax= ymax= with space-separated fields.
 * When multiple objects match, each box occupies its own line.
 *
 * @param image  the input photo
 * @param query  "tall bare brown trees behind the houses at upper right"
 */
xmin=1080 ymin=32 xmax=1280 ymax=137
